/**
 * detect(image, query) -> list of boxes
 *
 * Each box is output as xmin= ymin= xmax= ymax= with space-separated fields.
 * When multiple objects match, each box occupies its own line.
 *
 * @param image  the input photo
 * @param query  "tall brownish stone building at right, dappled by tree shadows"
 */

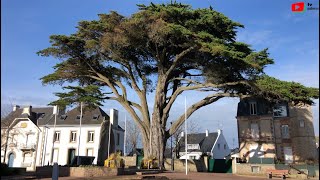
xmin=236 ymin=98 xmax=317 ymax=164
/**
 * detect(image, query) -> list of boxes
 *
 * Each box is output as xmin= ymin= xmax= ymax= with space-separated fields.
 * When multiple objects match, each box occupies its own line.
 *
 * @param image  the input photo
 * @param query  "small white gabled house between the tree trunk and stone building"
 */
xmin=179 ymin=129 xmax=231 ymax=159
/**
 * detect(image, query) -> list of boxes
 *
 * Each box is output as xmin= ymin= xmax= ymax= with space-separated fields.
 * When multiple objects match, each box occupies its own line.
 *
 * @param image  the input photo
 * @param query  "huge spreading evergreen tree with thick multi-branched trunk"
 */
xmin=38 ymin=2 xmax=319 ymax=168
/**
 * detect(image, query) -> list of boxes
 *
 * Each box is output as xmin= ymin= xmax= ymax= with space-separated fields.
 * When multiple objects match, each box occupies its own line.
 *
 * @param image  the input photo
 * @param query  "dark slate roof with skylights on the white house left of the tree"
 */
xmin=38 ymin=107 xmax=109 ymax=125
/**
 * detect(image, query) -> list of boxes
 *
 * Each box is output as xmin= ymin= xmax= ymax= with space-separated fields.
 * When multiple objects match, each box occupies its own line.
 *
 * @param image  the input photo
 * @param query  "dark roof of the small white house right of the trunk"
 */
xmin=180 ymin=132 xmax=218 ymax=152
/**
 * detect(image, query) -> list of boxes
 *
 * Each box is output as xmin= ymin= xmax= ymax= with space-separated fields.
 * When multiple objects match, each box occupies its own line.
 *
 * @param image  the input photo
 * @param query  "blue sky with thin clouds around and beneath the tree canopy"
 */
xmin=1 ymin=0 xmax=319 ymax=147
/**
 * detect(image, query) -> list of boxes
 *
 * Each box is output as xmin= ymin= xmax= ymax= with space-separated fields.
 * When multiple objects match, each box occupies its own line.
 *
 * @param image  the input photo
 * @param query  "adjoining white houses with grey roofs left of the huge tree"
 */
xmin=1 ymin=106 xmax=124 ymax=171
